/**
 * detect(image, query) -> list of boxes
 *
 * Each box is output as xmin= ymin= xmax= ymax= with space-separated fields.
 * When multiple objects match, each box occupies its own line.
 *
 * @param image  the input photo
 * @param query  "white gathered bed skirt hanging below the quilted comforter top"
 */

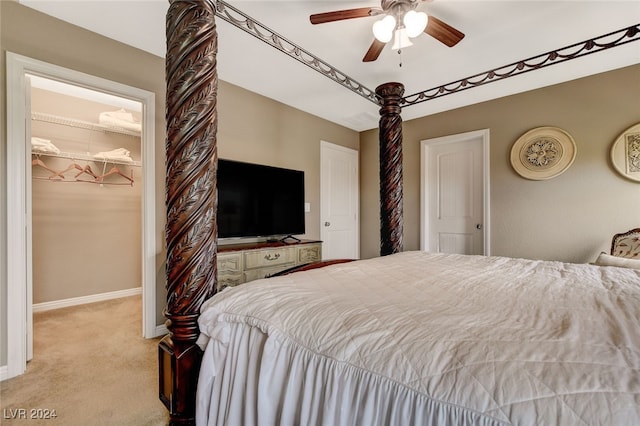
xmin=196 ymin=323 xmax=505 ymax=426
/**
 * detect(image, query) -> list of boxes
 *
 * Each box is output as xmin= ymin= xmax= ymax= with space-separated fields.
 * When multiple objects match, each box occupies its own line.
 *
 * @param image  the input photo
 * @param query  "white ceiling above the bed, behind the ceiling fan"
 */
xmin=20 ymin=0 xmax=640 ymax=131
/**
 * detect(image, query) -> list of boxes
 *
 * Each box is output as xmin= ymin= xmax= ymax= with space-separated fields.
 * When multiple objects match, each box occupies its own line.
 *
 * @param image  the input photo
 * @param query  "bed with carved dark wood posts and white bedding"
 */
xmin=158 ymin=0 xmax=640 ymax=425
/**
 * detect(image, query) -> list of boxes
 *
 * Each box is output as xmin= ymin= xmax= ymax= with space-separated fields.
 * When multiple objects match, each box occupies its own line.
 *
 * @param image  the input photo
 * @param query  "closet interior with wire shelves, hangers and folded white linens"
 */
xmin=28 ymin=77 xmax=143 ymax=318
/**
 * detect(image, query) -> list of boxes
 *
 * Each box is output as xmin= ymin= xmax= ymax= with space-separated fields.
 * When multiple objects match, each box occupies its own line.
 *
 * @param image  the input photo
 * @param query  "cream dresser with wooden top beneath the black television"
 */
xmin=217 ymin=240 xmax=322 ymax=291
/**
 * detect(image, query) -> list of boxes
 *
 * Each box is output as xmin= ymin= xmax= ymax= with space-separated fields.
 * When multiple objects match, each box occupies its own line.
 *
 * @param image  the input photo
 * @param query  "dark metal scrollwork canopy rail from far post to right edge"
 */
xmin=402 ymin=24 xmax=640 ymax=106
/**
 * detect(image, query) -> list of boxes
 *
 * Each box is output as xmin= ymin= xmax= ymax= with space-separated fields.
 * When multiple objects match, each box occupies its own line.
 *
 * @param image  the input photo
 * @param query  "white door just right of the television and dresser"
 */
xmin=320 ymin=142 xmax=360 ymax=259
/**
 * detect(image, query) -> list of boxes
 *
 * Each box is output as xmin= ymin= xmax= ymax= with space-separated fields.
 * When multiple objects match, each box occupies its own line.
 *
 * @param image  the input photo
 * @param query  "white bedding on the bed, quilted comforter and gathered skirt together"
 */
xmin=197 ymin=252 xmax=640 ymax=426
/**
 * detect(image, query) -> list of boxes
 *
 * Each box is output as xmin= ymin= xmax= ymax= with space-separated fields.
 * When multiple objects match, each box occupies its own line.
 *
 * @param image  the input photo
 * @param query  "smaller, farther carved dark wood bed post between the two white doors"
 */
xmin=376 ymin=83 xmax=404 ymax=256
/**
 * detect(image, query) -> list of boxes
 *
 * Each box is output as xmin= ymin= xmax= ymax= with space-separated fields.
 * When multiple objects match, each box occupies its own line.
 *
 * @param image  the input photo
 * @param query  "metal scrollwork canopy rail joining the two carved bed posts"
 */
xmin=215 ymin=0 xmax=378 ymax=104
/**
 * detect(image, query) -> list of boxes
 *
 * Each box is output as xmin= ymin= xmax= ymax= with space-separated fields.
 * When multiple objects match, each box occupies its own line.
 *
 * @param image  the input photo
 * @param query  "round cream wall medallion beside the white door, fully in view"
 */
xmin=511 ymin=126 xmax=576 ymax=180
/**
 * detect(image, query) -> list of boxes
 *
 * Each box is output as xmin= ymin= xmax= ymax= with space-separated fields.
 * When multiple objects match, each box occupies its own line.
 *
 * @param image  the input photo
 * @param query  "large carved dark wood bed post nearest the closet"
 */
xmin=158 ymin=0 xmax=218 ymax=425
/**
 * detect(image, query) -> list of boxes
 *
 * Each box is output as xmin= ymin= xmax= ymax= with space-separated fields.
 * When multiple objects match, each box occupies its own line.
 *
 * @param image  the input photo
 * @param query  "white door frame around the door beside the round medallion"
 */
xmin=420 ymin=129 xmax=491 ymax=256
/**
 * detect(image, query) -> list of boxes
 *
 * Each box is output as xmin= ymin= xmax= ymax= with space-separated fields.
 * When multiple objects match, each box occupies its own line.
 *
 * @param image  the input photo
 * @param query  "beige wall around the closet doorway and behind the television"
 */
xmin=0 ymin=1 xmax=359 ymax=365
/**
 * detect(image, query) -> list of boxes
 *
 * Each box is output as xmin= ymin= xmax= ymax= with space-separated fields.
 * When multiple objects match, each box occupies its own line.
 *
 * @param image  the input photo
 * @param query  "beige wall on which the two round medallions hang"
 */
xmin=360 ymin=65 xmax=640 ymax=262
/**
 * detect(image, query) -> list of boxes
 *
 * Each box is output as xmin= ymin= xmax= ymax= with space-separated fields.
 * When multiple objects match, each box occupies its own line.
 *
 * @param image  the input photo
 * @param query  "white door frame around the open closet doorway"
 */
xmin=3 ymin=52 xmax=158 ymax=378
